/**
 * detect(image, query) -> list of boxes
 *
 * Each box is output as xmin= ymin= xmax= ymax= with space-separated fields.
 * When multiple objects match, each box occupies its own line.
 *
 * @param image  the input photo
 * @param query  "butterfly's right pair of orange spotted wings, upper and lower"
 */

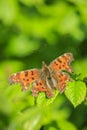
xmin=49 ymin=53 xmax=74 ymax=93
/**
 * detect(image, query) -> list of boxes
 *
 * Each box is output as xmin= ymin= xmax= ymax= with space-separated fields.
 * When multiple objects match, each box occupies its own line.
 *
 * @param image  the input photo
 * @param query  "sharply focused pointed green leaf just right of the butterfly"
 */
xmin=65 ymin=81 xmax=86 ymax=107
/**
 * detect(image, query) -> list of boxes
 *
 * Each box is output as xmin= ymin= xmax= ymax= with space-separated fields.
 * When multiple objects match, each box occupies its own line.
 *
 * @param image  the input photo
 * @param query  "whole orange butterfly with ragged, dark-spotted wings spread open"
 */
xmin=9 ymin=53 xmax=74 ymax=98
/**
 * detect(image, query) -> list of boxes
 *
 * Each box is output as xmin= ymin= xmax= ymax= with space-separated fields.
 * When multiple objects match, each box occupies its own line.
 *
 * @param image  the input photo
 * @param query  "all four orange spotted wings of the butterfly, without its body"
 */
xmin=9 ymin=53 xmax=73 ymax=97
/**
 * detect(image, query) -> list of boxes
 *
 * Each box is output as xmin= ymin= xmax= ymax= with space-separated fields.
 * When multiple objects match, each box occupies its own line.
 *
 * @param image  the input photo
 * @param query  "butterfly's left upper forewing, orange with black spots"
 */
xmin=9 ymin=69 xmax=40 ymax=90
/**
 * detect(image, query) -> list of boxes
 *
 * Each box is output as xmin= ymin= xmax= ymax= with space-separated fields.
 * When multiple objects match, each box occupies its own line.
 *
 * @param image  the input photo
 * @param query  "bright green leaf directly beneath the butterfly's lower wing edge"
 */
xmin=36 ymin=90 xmax=58 ymax=106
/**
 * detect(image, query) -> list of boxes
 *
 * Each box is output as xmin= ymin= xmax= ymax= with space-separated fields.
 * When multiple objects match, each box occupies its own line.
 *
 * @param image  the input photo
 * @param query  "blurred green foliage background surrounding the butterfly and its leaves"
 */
xmin=0 ymin=0 xmax=87 ymax=130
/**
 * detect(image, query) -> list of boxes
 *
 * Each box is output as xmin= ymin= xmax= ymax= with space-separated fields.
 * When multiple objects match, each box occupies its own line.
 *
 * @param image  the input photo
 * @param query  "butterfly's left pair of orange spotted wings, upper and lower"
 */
xmin=9 ymin=69 xmax=53 ymax=97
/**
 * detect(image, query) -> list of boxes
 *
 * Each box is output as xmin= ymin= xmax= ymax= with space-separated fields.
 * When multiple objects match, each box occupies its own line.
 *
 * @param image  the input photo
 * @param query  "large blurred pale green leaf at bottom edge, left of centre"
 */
xmin=7 ymin=107 xmax=43 ymax=130
